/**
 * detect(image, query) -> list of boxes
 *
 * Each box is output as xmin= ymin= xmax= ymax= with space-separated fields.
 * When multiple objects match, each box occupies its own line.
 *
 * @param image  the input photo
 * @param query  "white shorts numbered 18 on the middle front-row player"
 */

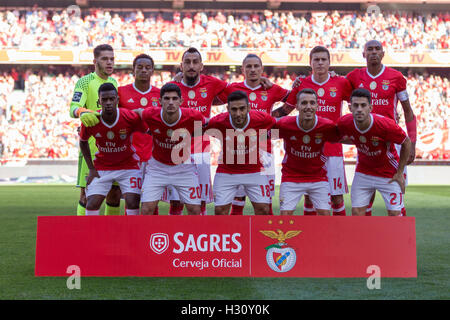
xmin=213 ymin=172 xmax=271 ymax=206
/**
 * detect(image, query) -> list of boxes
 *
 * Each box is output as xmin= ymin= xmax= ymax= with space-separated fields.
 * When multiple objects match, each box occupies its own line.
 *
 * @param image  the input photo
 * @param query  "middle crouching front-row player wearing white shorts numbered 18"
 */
xmin=206 ymin=91 xmax=276 ymax=215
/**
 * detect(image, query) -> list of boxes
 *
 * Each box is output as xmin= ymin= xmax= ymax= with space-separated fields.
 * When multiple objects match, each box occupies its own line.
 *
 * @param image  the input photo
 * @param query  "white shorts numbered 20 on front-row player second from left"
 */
xmin=141 ymin=158 xmax=201 ymax=204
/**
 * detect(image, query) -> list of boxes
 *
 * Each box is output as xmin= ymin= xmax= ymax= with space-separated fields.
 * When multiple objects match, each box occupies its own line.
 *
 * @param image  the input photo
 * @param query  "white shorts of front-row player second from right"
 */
xmin=280 ymin=181 xmax=331 ymax=210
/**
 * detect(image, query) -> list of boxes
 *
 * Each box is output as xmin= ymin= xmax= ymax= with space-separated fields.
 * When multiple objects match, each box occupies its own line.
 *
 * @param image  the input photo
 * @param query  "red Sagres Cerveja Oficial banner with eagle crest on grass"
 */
xmin=35 ymin=216 xmax=417 ymax=277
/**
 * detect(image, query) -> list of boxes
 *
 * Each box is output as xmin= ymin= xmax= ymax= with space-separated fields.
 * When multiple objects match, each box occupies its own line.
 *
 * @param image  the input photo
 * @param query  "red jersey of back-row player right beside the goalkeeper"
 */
xmin=119 ymin=83 xmax=160 ymax=162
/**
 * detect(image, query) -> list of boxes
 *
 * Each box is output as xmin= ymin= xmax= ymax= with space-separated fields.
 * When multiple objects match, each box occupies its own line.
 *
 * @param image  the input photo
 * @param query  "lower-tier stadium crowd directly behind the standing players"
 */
xmin=0 ymin=70 xmax=450 ymax=163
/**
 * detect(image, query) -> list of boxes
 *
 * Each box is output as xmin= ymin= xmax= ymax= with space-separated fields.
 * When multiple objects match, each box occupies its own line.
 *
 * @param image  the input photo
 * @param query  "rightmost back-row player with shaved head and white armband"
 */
xmin=346 ymin=40 xmax=417 ymax=216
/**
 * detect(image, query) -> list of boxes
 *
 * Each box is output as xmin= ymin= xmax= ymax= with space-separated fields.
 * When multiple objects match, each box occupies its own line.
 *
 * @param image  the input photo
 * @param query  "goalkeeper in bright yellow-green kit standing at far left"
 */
xmin=69 ymin=44 xmax=121 ymax=215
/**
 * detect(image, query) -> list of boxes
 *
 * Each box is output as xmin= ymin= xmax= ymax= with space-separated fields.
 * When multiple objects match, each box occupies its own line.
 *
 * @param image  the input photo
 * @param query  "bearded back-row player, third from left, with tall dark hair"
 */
xmin=165 ymin=48 xmax=228 ymax=215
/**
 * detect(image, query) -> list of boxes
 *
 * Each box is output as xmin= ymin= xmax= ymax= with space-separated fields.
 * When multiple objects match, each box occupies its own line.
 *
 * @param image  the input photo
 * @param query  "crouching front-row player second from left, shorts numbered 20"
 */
xmin=136 ymin=83 xmax=204 ymax=214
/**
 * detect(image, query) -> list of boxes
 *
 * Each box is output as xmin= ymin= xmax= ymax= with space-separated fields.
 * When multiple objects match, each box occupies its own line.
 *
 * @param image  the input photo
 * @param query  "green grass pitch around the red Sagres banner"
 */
xmin=0 ymin=184 xmax=450 ymax=300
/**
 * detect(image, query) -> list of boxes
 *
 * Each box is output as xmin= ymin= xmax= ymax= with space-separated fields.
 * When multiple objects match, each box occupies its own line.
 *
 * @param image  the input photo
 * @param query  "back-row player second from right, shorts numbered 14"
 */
xmin=280 ymin=46 xmax=352 ymax=216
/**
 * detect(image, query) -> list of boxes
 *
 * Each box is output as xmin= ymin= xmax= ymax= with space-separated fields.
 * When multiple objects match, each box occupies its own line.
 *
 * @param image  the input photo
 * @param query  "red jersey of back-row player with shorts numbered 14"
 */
xmin=286 ymin=75 xmax=352 ymax=157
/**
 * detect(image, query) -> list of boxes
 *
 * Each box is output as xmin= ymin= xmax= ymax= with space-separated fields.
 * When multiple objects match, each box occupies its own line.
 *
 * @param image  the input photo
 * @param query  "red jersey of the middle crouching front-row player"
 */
xmin=206 ymin=111 xmax=276 ymax=174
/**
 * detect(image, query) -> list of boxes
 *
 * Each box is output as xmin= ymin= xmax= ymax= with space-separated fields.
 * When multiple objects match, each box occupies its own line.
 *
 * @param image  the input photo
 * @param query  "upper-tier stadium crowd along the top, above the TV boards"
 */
xmin=0 ymin=7 xmax=450 ymax=49
